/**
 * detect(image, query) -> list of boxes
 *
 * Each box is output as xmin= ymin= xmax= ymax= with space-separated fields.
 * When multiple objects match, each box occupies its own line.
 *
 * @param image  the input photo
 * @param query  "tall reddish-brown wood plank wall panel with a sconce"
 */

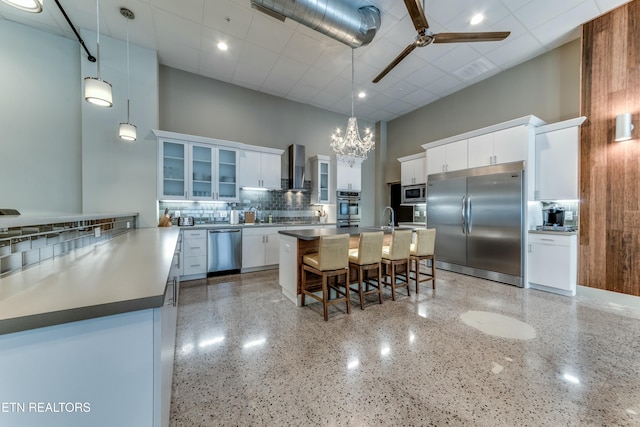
xmin=578 ymin=0 xmax=640 ymax=296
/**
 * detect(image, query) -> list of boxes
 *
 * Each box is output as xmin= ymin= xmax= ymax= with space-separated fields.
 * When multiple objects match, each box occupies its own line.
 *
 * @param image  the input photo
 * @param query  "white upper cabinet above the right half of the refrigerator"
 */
xmin=468 ymin=125 xmax=527 ymax=168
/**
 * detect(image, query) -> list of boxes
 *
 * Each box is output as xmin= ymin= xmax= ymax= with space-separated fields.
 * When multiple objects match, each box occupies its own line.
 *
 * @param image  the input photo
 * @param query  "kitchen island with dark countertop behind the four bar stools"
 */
xmin=279 ymin=227 xmax=415 ymax=306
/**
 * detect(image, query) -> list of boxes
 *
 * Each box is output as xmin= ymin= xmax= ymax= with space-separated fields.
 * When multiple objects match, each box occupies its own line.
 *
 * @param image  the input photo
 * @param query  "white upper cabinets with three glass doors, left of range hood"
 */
xmin=153 ymin=130 xmax=284 ymax=202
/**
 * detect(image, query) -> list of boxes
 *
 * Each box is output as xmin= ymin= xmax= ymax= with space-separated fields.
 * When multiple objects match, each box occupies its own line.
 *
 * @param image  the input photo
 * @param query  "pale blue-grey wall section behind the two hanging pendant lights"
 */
xmin=79 ymin=30 xmax=158 ymax=231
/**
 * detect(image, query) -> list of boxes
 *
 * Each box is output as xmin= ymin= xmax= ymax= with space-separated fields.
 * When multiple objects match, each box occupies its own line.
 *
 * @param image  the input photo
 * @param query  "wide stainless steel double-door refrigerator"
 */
xmin=427 ymin=162 xmax=524 ymax=287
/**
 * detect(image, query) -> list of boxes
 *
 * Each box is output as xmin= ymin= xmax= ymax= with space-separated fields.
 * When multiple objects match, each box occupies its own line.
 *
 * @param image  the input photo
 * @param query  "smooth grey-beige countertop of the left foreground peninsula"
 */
xmin=0 ymin=229 xmax=180 ymax=333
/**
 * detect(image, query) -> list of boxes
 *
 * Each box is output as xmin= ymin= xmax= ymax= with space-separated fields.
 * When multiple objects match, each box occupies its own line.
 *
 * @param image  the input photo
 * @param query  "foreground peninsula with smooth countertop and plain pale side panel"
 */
xmin=0 ymin=227 xmax=180 ymax=426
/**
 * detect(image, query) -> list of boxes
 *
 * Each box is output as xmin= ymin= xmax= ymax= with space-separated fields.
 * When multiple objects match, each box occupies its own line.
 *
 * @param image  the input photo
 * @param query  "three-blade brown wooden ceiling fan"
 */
xmin=373 ymin=0 xmax=511 ymax=83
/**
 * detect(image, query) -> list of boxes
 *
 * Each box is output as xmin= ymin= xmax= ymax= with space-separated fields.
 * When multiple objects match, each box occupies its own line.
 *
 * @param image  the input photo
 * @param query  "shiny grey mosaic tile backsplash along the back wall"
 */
xmin=158 ymin=179 xmax=328 ymax=224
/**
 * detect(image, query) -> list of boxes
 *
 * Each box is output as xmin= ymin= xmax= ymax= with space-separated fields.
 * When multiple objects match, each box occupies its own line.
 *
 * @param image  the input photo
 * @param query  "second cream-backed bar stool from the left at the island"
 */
xmin=349 ymin=231 xmax=384 ymax=310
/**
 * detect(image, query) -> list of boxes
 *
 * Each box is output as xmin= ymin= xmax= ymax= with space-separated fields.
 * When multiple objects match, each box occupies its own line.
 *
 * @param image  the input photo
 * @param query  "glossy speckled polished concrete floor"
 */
xmin=171 ymin=270 xmax=640 ymax=426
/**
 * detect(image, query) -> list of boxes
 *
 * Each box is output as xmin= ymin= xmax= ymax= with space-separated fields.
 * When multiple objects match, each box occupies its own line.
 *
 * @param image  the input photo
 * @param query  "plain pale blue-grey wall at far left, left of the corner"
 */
xmin=0 ymin=20 xmax=82 ymax=213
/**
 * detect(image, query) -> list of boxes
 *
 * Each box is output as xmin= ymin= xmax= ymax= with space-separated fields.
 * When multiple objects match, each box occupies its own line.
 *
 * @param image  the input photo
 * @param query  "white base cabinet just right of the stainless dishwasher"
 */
xmin=242 ymin=227 xmax=285 ymax=271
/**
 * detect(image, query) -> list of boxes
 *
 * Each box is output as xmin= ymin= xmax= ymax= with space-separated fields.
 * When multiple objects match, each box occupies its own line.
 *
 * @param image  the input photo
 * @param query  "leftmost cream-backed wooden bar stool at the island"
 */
xmin=300 ymin=234 xmax=351 ymax=321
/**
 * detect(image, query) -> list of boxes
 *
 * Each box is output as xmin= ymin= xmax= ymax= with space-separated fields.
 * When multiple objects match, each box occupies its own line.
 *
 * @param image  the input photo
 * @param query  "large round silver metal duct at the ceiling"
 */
xmin=251 ymin=0 xmax=380 ymax=48
